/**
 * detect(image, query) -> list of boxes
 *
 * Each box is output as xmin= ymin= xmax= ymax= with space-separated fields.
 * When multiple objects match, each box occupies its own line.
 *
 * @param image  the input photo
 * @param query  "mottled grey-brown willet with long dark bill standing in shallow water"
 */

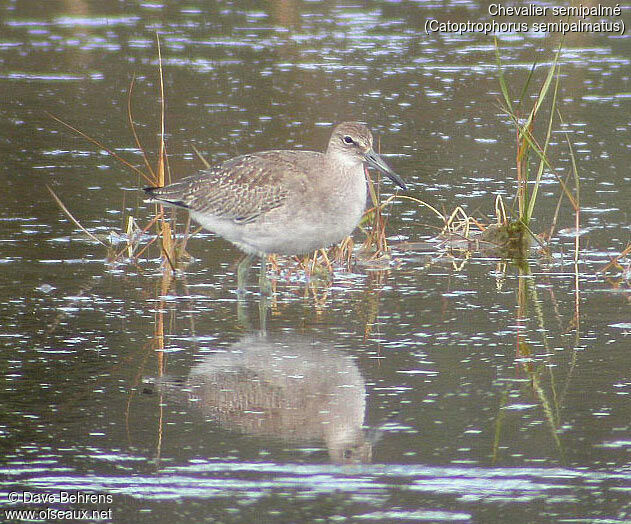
xmin=145 ymin=122 xmax=406 ymax=294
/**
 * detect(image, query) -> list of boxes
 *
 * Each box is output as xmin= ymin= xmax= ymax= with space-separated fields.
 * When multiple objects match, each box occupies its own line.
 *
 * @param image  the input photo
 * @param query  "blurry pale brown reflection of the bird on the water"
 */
xmin=180 ymin=334 xmax=372 ymax=463
